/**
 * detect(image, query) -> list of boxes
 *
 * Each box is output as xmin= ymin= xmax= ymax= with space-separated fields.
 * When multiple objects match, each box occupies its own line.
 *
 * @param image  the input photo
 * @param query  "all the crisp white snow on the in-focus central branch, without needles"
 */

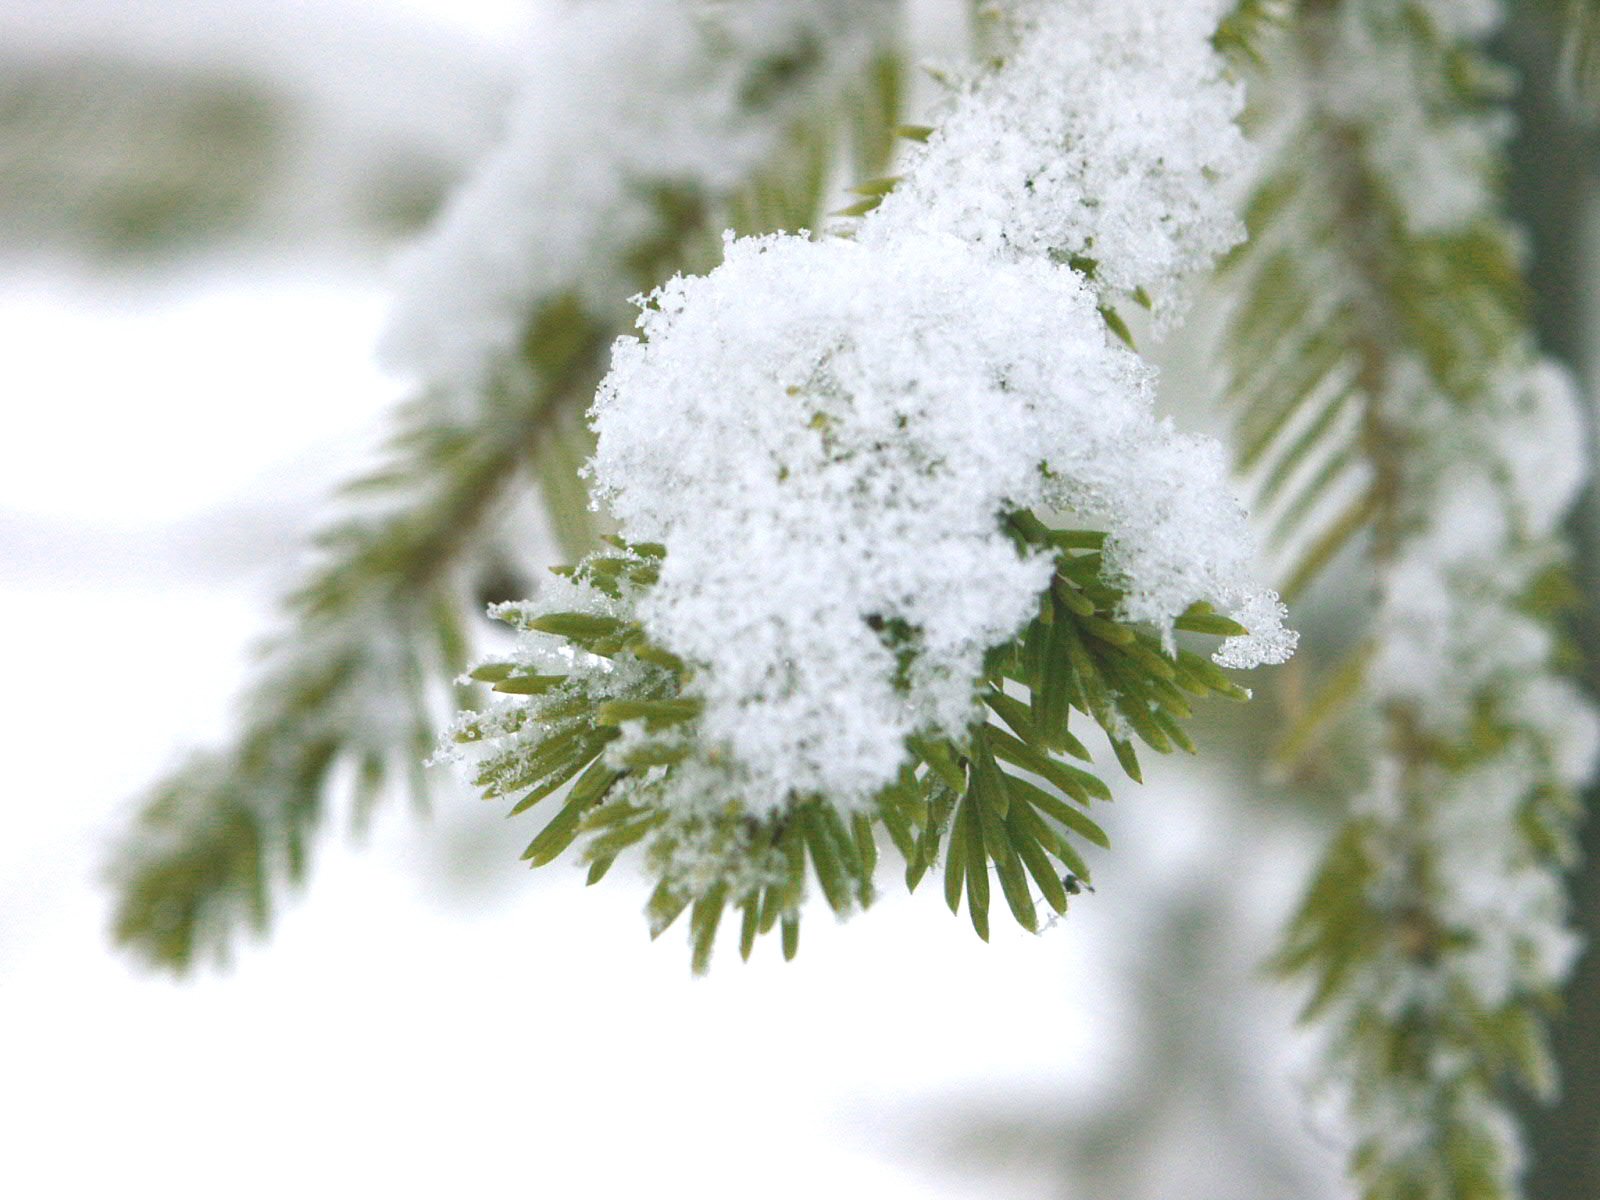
xmin=594 ymin=0 xmax=1293 ymax=808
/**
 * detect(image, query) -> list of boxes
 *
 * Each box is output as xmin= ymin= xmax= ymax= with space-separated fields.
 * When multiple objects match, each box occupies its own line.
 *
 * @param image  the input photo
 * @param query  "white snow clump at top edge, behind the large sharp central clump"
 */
xmin=869 ymin=0 xmax=1248 ymax=321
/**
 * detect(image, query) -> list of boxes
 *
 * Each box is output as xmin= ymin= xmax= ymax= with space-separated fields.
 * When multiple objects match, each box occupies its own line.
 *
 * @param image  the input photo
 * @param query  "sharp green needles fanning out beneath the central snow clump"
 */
xmin=451 ymin=531 xmax=1250 ymax=973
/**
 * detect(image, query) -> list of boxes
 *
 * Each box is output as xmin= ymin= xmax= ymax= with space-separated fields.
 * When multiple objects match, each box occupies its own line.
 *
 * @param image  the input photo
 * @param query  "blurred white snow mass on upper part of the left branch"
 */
xmin=382 ymin=0 xmax=893 ymax=404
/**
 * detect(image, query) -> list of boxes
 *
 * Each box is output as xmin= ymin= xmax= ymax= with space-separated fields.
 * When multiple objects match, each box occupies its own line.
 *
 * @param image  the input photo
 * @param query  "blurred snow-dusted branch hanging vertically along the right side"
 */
xmin=1230 ymin=0 xmax=1600 ymax=1200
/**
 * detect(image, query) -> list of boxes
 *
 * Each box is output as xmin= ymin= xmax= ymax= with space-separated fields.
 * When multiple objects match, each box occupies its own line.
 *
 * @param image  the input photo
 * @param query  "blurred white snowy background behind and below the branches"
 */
xmin=0 ymin=0 xmax=1600 ymax=1200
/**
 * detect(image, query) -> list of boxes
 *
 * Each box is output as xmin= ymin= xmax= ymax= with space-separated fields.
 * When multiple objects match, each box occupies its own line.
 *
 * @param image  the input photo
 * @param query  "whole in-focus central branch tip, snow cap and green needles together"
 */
xmin=441 ymin=0 xmax=1294 ymax=965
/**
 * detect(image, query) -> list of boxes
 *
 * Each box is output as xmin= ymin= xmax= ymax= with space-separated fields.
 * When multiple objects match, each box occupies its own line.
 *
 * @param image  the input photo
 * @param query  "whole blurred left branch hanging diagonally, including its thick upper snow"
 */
xmin=112 ymin=0 xmax=898 ymax=970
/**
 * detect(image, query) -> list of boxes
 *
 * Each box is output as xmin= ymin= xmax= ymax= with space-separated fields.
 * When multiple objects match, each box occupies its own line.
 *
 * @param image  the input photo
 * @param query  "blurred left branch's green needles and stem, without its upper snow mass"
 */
xmin=112 ymin=4 xmax=899 ymax=971
